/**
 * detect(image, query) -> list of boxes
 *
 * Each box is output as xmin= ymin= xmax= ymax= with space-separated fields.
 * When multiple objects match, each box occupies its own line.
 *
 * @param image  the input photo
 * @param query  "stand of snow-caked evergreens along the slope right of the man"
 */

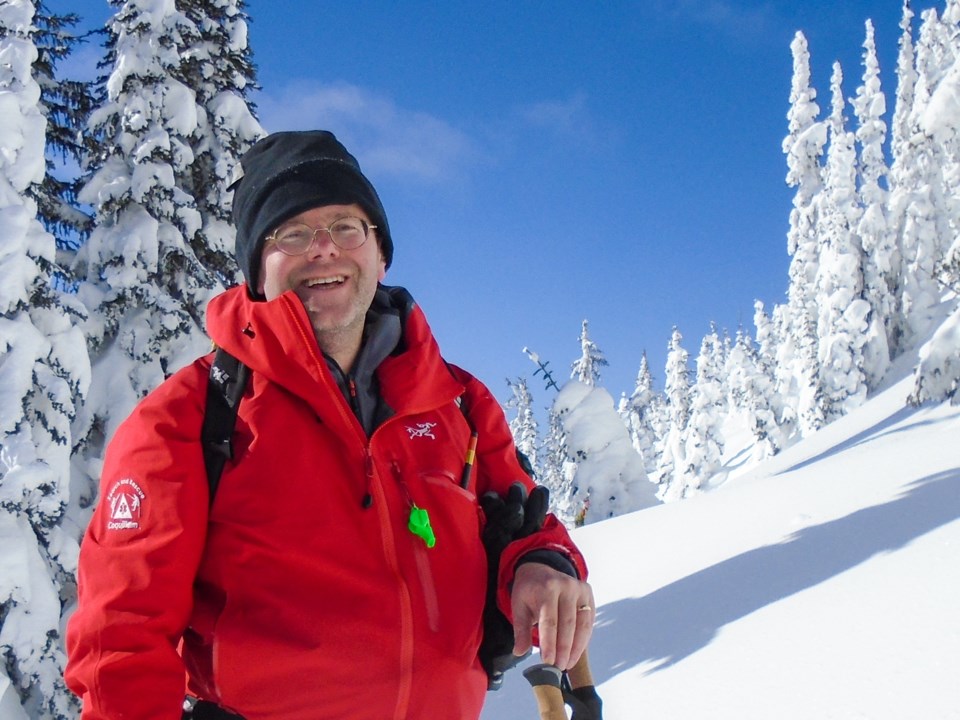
xmin=508 ymin=0 xmax=960 ymax=523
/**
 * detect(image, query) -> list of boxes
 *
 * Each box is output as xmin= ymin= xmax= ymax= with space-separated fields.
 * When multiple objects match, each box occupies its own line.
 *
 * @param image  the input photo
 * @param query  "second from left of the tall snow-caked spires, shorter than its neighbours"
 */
xmin=816 ymin=63 xmax=871 ymax=423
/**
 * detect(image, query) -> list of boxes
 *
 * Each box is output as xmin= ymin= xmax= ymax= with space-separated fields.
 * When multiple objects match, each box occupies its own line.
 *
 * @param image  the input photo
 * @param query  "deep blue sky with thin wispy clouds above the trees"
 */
xmin=56 ymin=0 xmax=928 ymax=406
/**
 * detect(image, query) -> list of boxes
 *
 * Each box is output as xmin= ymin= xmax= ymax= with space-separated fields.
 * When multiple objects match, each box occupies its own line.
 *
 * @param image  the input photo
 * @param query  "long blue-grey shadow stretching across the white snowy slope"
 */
xmin=590 ymin=468 xmax=960 ymax=684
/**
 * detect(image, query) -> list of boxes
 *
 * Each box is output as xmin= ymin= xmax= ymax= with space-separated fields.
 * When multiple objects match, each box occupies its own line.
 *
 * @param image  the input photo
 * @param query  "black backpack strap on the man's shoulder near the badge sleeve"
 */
xmin=200 ymin=348 xmax=250 ymax=505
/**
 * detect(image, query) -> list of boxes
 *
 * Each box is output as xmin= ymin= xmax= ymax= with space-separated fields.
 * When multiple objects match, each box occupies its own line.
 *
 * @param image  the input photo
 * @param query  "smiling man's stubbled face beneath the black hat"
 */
xmin=258 ymin=205 xmax=386 ymax=352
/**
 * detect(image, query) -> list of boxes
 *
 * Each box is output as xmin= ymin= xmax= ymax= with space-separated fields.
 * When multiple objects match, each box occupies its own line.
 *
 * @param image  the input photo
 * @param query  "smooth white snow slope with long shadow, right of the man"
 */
xmin=482 ymin=373 xmax=960 ymax=720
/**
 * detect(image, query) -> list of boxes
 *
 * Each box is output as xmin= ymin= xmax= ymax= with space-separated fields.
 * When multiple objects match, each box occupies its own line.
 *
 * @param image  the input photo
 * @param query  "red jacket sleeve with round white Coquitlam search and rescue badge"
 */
xmin=65 ymin=362 xmax=208 ymax=720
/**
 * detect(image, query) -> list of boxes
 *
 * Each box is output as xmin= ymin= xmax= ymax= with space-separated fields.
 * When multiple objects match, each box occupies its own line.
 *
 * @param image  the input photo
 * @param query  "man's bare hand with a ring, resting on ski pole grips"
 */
xmin=510 ymin=562 xmax=596 ymax=670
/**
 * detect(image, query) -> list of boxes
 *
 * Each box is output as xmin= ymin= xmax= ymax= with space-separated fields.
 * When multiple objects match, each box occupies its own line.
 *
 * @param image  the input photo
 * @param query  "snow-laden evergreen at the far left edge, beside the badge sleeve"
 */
xmin=0 ymin=0 xmax=90 ymax=719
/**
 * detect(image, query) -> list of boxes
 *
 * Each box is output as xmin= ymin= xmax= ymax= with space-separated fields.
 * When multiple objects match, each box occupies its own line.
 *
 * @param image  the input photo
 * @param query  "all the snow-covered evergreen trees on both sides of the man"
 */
xmin=0 ymin=0 xmax=960 ymax=720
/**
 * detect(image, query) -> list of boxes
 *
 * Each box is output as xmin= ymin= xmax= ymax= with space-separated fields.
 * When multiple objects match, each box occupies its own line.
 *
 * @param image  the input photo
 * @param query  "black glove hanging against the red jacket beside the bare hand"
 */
xmin=478 ymin=482 xmax=550 ymax=690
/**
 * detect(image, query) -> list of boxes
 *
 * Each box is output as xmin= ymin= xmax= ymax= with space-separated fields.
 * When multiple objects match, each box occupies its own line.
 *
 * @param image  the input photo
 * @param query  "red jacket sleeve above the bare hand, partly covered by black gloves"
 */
xmin=454 ymin=368 xmax=587 ymax=621
